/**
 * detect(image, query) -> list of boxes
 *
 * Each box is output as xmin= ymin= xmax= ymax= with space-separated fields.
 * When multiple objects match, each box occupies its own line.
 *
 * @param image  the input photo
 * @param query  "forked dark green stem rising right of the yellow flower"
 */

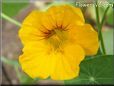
xmin=95 ymin=1 xmax=108 ymax=54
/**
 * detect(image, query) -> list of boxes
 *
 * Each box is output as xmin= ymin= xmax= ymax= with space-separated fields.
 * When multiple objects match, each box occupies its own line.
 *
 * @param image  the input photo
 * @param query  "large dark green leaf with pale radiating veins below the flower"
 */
xmin=65 ymin=55 xmax=114 ymax=85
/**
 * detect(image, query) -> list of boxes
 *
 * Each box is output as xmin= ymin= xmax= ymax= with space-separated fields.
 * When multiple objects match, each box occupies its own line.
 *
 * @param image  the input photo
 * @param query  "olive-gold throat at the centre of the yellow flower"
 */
xmin=47 ymin=28 xmax=67 ymax=49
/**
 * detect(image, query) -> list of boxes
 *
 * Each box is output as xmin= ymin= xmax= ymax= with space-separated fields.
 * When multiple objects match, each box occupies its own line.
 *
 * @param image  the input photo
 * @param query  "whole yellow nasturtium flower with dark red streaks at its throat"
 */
xmin=19 ymin=5 xmax=99 ymax=80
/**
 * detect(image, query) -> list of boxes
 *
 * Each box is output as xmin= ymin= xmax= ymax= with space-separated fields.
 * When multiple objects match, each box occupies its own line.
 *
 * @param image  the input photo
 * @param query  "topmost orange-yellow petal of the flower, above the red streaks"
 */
xmin=47 ymin=5 xmax=84 ymax=27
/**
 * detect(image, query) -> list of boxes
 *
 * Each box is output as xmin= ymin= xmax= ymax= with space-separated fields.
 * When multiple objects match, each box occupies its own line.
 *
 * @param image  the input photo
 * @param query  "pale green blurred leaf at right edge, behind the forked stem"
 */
xmin=103 ymin=29 xmax=114 ymax=55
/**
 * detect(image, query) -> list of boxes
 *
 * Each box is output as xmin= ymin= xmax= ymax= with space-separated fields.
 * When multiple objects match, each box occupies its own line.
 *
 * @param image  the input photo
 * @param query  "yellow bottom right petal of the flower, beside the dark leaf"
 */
xmin=51 ymin=44 xmax=85 ymax=80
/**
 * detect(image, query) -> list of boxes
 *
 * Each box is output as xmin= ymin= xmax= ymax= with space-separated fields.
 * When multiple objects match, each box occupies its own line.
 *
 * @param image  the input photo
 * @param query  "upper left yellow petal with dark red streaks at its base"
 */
xmin=19 ymin=11 xmax=57 ymax=45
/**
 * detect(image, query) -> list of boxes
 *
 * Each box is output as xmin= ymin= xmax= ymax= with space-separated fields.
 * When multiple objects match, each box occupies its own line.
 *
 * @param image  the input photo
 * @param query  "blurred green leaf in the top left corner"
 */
xmin=2 ymin=2 xmax=28 ymax=17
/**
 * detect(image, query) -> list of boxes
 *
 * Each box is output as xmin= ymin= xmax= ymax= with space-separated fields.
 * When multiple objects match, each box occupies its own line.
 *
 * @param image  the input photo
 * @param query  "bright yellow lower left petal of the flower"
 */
xmin=19 ymin=42 xmax=56 ymax=79
